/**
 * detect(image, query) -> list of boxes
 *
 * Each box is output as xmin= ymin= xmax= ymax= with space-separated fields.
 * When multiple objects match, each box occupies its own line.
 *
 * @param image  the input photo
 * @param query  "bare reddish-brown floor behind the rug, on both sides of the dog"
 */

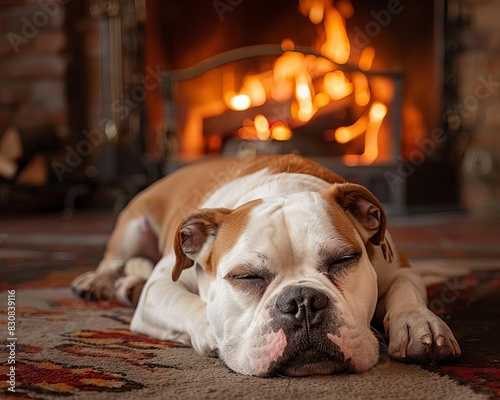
xmin=0 ymin=211 xmax=500 ymax=260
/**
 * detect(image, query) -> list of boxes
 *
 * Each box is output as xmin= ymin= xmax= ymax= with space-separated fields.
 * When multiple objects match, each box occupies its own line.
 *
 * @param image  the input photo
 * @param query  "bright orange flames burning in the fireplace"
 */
xmin=224 ymin=0 xmax=392 ymax=165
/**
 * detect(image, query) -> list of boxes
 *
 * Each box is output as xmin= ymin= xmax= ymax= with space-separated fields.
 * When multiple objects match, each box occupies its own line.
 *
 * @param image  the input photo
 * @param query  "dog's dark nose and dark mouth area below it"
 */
xmin=269 ymin=285 xmax=353 ymax=376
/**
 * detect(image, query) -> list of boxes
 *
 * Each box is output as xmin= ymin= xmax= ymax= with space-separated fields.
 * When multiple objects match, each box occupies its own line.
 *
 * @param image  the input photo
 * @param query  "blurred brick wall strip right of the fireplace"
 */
xmin=456 ymin=0 xmax=500 ymax=213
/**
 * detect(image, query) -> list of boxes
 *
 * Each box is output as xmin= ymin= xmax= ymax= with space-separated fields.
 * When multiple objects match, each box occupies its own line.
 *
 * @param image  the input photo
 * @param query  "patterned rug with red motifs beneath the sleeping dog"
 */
xmin=0 ymin=245 xmax=500 ymax=400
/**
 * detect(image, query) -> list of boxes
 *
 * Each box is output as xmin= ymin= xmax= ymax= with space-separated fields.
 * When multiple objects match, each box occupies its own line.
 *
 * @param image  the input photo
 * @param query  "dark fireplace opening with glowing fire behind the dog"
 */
xmin=139 ymin=0 xmax=456 ymax=210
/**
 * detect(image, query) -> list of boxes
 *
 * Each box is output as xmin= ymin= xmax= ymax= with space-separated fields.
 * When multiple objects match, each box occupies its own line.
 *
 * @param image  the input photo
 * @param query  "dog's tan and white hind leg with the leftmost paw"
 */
xmin=71 ymin=208 xmax=160 ymax=300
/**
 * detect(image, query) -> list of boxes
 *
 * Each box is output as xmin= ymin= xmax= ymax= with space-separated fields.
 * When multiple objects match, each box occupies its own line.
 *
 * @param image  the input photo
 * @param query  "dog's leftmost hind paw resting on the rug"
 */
xmin=71 ymin=271 xmax=117 ymax=301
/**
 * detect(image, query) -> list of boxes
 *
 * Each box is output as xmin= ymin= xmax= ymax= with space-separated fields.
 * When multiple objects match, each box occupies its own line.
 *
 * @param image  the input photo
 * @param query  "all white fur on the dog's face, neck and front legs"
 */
xmin=131 ymin=169 xmax=460 ymax=376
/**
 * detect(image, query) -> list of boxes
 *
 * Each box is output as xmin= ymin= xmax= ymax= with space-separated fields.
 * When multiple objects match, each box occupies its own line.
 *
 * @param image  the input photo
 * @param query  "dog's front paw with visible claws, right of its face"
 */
xmin=384 ymin=307 xmax=461 ymax=364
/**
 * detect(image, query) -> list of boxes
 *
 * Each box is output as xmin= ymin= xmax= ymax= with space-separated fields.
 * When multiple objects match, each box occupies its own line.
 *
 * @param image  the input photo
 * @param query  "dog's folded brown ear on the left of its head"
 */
xmin=172 ymin=208 xmax=231 ymax=282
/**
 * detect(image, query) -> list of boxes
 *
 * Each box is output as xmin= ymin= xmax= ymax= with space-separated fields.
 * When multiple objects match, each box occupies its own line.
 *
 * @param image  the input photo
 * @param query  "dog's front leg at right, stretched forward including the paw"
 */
xmin=376 ymin=239 xmax=460 ymax=363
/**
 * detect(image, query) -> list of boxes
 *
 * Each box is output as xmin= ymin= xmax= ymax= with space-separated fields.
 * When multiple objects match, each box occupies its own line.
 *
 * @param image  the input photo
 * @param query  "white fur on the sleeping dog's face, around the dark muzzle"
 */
xmin=207 ymin=192 xmax=378 ymax=375
